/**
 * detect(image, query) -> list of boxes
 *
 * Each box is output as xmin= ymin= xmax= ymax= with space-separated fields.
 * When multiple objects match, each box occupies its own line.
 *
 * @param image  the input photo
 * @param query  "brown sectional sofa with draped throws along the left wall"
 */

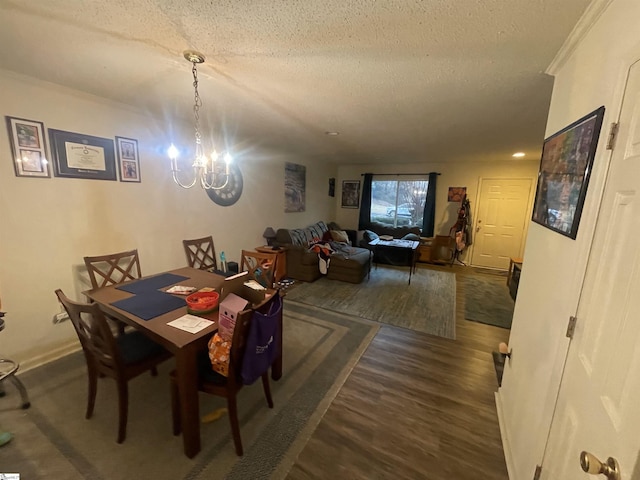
xmin=274 ymin=221 xmax=372 ymax=283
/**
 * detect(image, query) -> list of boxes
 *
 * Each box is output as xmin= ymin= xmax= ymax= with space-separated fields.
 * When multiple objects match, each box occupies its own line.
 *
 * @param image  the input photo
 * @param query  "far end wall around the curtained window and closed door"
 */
xmin=335 ymin=159 xmax=542 ymax=259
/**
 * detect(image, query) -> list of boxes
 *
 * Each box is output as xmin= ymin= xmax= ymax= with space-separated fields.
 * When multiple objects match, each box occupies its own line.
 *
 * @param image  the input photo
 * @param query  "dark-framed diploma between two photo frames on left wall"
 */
xmin=49 ymin=128 xmax=118 ymax=181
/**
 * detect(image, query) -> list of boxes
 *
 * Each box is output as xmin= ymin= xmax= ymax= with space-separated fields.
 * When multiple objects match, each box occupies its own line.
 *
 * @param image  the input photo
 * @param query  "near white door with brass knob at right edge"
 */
xmin=541 ymin=58 xmax=640 ymax=480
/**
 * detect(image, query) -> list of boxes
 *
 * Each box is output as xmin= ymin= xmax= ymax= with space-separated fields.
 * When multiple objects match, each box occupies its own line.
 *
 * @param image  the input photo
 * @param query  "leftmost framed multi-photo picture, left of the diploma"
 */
xmin=5 ymin=117 xmax=51 ymax=178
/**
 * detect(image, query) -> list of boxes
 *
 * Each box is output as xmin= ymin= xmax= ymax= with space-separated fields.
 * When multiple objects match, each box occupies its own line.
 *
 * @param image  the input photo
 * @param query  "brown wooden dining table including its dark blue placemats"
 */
xmin=83 ymin=267 xmax=282 ymax=458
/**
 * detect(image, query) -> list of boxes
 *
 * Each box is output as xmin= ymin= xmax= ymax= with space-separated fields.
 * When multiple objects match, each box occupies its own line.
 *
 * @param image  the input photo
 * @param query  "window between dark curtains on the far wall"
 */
xmin=370 ymin=179 xmax=429 ymax=227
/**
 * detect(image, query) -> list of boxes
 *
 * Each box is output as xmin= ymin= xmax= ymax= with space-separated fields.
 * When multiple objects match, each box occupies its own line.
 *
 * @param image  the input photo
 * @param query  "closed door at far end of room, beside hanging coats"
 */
xmin=471 ymin=178 xmax=532 ymax=270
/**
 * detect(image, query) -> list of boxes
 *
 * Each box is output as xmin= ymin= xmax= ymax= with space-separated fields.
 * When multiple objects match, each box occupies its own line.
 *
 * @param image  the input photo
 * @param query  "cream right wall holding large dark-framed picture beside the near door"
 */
xmin=497 ymin=0 xmax=640 ymax=479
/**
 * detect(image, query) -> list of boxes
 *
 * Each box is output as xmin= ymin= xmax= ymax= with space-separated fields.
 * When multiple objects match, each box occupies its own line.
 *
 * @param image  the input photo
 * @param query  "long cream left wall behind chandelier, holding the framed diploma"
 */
xmin=0 ymin=71 xmax=335 ymax=368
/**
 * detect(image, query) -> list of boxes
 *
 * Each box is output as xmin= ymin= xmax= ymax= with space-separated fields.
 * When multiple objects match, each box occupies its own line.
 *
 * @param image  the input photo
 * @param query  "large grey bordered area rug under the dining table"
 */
xmin=0 ymin=299 xmax=379 ymax=480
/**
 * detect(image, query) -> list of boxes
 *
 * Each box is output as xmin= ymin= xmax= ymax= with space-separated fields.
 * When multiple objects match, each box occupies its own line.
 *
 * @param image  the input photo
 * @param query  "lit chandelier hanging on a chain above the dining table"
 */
xmin=167 ymin=50 xmax=232 ymax=190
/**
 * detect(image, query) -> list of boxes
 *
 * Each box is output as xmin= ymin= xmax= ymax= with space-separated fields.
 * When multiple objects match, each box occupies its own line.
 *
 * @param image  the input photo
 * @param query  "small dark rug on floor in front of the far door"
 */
xmin=460 ymin=274 xmax=514 ymax=328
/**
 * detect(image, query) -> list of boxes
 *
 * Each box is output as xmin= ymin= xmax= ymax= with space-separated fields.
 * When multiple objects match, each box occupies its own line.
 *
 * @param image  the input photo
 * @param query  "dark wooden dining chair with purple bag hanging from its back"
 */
xmin=169 ymin=291 xmax=282 ymax=456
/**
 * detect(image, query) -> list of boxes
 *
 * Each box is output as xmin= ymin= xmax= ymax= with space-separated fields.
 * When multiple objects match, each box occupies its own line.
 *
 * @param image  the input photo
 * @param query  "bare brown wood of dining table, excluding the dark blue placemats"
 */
xmin=84 ymin=267 xmax=282 ymax=458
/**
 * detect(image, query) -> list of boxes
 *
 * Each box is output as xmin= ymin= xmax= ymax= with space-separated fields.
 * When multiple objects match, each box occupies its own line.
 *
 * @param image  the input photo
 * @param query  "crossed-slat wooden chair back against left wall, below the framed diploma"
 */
xmin=84 ymin=250 xmax=142 ymax=288
